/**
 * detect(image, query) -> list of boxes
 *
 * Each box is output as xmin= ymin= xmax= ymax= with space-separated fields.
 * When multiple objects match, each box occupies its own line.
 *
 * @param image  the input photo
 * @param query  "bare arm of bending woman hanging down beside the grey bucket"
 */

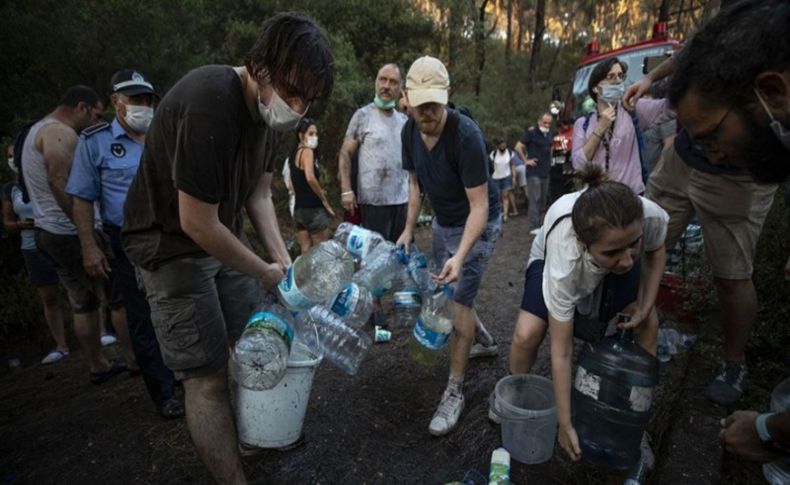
xmin=549 ymin=313 xmax=581 ymax=461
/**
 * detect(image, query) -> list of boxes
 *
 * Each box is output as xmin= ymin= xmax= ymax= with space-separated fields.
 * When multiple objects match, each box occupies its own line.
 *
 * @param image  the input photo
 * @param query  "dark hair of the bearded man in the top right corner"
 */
xmin=669 ymin=0 xmax=790 ymax=107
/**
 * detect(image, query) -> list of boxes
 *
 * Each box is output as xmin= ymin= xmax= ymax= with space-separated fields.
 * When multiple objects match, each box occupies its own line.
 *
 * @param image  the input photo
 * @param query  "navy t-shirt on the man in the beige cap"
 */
xmin=403 ymin=113 xmax=499 ymax=227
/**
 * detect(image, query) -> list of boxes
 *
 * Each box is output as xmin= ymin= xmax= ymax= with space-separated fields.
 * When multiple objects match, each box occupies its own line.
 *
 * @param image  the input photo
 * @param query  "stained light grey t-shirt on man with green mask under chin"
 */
xmin=346 ymin=103 xmax=409 ymax=205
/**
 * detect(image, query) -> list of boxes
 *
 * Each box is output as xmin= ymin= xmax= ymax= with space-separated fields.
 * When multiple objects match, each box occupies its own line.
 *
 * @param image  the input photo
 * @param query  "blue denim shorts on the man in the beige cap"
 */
xmin=432 ymin=218 xmax=502 ymax=308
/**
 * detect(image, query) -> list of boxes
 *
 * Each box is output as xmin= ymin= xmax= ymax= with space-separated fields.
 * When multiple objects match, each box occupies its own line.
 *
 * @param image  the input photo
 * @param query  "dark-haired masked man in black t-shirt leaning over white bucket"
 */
xmin=122 ymin=13 xmax=334 ymax=483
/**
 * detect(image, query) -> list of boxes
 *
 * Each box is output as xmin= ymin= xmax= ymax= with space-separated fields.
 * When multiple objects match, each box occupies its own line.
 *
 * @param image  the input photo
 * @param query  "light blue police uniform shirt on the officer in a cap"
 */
xmin=66 ymin=118 xmax=143 ymax=227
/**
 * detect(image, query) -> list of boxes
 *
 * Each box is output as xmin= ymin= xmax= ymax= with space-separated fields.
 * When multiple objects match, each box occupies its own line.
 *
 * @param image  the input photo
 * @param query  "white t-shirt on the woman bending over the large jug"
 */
xmin=527 ymin=191 xmax=669 ymax=321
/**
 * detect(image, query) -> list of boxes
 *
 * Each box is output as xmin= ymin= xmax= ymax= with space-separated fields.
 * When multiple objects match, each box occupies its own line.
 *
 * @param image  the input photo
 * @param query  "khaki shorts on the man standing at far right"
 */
xmin=645 ymin=146 xmax=777 ymax=280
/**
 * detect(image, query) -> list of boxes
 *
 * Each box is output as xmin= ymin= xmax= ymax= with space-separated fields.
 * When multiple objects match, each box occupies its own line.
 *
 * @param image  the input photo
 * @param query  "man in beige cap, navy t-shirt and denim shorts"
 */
xmin=398 ymin=56 xmax=502 ymax=436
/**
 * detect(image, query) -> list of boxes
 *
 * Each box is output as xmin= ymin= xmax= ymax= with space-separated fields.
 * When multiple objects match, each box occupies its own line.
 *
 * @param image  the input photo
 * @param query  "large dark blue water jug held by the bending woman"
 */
xmin=571 ymin=331 xmax=658 ymax=470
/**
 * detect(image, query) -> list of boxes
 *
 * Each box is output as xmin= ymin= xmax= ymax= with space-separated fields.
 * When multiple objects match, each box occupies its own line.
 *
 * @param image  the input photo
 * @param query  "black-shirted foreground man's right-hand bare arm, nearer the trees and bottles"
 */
xmin=245 ymin=173 xmax=291 ymax=270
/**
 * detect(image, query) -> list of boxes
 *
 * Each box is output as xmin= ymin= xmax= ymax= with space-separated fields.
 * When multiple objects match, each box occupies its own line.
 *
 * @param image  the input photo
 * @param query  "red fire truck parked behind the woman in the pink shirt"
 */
xmin=550 ymin=22 xmax=680 ymax=200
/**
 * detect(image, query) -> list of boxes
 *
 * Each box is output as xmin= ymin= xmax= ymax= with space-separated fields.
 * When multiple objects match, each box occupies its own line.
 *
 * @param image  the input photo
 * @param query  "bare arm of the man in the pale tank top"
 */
xmin=36 ymin=123 xmax=78 ymax=219
